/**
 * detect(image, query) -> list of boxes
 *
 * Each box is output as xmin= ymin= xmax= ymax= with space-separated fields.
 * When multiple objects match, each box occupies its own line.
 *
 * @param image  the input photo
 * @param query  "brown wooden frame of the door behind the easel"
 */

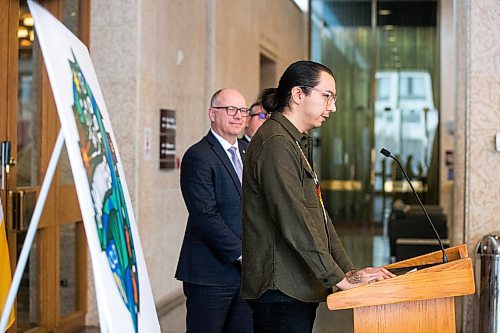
xmin=0 ymin=0 xmax=90 ymax=332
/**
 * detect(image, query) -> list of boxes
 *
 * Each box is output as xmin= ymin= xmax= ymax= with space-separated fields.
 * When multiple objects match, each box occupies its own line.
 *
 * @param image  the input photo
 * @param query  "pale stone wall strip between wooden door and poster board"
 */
xmin=87 ymin=0 xmax=141 ymax=325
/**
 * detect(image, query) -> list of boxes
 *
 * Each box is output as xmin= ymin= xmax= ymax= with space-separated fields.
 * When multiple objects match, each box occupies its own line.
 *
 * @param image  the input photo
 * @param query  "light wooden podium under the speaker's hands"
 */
xmin=327 ymin=245 xmax=475 ymax=333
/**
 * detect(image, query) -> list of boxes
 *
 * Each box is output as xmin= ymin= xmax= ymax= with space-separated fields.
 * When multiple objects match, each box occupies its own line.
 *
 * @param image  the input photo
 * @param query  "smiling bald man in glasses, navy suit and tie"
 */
xmin=175 ymin=88 xmax=252 ymax=333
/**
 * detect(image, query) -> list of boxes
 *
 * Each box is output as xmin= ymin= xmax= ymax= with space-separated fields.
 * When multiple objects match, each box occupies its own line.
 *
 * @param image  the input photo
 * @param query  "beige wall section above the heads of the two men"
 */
xmin=214 ymin=0 xmax=309 ymax=101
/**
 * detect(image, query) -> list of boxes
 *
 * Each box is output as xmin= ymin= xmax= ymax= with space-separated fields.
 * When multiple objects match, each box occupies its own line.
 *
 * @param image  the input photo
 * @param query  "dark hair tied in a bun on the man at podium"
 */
xmin=262 ymin=60 xmax=333 ymax=112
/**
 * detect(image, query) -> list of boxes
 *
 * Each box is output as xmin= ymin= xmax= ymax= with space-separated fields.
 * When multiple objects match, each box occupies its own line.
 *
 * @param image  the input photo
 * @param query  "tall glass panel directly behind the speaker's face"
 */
xmin=311 ymin=0 xmax=375 ymax=225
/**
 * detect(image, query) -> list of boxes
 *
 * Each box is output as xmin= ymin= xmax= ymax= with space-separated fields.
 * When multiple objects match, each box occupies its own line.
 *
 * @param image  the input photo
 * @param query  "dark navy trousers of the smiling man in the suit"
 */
xmin=183 ymin=282 xmax=252 ymax=333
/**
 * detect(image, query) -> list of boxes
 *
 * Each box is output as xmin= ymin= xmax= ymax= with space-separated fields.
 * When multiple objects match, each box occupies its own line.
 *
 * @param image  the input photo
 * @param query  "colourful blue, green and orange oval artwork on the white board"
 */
xmin=69 ymin=53 xmax=140 ymax=332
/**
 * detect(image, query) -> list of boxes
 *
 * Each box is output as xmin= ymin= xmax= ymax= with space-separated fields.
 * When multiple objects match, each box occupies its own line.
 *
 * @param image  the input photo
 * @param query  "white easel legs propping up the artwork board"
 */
xmin=0 ymin=129 xmax=108 ymax=333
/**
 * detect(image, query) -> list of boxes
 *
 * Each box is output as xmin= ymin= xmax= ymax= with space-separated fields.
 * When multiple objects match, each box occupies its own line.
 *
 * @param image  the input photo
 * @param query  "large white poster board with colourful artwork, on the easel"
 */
xmin=28 ymin=0 xmax=160 ymax=333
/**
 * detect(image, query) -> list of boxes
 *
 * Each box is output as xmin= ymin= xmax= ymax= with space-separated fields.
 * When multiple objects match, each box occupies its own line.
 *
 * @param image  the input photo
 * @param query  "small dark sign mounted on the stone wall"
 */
xmin=159 ymin=109 xmax=177 ymax=170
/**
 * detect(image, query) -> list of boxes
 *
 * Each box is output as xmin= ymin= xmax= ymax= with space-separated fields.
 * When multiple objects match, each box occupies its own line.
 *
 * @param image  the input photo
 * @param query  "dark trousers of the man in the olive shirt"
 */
xmin=248 ymin=300 xmax=318 ymax=333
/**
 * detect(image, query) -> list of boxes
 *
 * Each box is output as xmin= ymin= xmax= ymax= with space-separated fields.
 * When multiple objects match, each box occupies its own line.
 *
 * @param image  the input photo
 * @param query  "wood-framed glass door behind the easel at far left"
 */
xmin=0 ymin=0 xmax=88 ymax=332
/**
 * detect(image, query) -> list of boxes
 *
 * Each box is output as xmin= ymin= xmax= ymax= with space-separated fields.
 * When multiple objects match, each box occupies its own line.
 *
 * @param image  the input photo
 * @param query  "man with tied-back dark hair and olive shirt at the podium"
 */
xmin=241 ymin=61 xmax=394 ymax=332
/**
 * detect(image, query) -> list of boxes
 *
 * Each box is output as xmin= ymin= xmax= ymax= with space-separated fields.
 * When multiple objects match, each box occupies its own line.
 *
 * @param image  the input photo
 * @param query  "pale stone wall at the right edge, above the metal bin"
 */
xmin=465 ymin=0 xmax=500 ymax=248
